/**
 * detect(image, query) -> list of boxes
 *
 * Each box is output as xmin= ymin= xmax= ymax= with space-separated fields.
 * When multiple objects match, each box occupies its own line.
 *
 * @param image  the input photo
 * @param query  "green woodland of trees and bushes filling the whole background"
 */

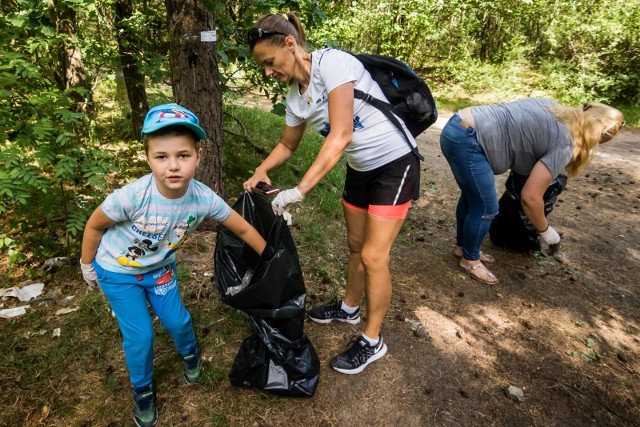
xmin=0 ymin=0 xmax=640 ymax=270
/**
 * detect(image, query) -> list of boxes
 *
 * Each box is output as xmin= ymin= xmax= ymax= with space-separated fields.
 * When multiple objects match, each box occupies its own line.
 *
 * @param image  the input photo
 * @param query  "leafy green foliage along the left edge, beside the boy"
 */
xmin=0 ymin=1 xmax=113 ymax=262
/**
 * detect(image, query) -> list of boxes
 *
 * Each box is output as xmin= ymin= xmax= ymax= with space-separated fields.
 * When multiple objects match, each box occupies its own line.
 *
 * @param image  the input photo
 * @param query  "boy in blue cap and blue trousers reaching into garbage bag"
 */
xmin=80 ymin=104 xmax=266 ymax=427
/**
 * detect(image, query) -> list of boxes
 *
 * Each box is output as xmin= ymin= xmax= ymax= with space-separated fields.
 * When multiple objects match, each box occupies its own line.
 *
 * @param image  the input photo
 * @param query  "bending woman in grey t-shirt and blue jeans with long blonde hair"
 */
xmin=440 ymin=98 xmax=624 ymax=285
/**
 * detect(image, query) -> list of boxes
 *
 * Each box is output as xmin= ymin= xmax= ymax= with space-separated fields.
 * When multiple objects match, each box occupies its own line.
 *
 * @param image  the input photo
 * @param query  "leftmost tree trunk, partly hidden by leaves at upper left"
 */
xmin=50 ymin=0 xmax=94 ymax=114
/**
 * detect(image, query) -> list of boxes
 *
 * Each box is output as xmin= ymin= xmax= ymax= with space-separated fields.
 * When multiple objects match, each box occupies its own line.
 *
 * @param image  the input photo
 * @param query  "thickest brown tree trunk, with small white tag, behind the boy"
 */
xmin=165 ymin=0 xmax=225 ymax=229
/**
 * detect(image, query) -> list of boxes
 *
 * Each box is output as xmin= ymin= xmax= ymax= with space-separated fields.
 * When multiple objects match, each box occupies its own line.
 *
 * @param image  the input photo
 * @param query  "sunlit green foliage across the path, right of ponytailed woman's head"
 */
xmin=311 ymin=0 xmax=640 ymax=104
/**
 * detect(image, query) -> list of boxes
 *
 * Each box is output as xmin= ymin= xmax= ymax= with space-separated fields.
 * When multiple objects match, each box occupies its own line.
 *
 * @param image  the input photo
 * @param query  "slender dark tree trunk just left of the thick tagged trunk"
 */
xmin=115 ymin=0 xmax=149 ymax=139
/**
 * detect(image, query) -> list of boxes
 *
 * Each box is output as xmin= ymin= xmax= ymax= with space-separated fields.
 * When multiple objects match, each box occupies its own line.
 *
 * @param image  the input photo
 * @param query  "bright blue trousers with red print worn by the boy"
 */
xmin=93 ymin=261 xmax=196 ymax=389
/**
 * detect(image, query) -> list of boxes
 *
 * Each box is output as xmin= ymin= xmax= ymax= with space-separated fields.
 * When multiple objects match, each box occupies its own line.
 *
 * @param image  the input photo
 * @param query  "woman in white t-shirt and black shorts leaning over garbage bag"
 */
xmin=244 ymin=13 xmax=420 ymax=374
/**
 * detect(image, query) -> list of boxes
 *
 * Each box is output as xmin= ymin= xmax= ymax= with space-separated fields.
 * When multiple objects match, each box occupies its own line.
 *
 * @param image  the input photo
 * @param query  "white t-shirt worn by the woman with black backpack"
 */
xmin=286 ymin=49 xmax=416 ymax=172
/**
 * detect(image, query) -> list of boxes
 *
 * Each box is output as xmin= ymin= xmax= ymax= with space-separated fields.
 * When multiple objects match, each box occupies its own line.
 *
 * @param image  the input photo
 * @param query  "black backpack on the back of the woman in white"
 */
xmin=318 ymin=51 xmax=438 ymax=160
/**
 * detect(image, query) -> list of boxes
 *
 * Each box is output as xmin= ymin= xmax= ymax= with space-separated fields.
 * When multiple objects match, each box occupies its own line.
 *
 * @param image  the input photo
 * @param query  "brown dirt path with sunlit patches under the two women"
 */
xmin=266 ymin=114 xmax=640 ymax=426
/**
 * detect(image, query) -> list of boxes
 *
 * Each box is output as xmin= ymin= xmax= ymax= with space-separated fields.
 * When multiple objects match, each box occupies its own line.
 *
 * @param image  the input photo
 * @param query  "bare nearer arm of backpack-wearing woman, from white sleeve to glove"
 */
xmin=297 ymin=82 xmax=353 ymax=196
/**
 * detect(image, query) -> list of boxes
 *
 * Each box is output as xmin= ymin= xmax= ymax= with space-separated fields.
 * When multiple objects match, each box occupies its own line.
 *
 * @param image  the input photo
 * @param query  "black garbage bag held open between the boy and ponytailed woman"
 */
xmin=214 ymin=192 xmax=320 ymax=396
